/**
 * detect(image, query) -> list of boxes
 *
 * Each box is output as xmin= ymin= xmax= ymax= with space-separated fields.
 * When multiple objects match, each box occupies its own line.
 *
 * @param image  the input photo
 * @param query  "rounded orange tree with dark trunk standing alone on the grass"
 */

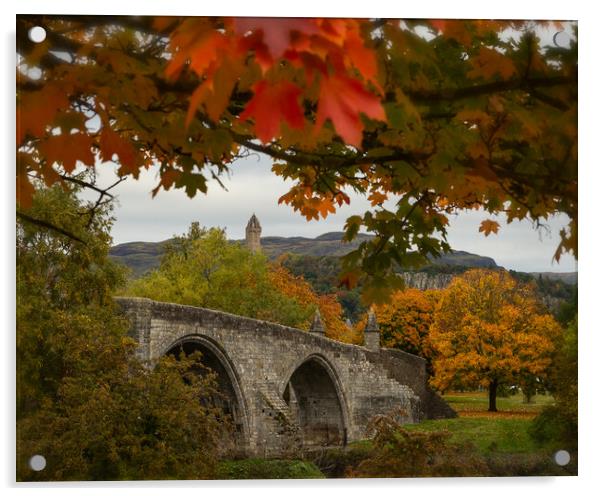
xmin=429 ymin=269 xmax=561 ymax=412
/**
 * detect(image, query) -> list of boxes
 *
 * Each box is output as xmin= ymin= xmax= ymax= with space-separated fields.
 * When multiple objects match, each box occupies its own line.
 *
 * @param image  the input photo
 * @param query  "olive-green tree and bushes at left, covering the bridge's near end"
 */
xmin=17 ymin=187 xmax=227 ymax=481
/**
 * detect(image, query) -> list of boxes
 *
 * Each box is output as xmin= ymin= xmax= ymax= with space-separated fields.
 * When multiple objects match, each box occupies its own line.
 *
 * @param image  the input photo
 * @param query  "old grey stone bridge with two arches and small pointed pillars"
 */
xmin=117 ymin=298 xmax=455 ymax=456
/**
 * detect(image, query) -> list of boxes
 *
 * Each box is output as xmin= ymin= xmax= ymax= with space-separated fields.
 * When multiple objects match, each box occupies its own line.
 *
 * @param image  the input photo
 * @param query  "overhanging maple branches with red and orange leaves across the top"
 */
xmin=16 ymin=15 xmax=577 ymax=301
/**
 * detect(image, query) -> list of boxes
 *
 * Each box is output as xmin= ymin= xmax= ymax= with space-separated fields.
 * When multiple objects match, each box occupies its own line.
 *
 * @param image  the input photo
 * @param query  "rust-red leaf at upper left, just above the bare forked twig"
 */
xmin=38 ymin=133 xmax=94 ymax=173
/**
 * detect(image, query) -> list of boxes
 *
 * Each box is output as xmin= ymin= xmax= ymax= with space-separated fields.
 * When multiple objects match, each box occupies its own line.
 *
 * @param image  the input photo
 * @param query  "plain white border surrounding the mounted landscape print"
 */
xmin=0 ymin=0 xmax=602 ymax=496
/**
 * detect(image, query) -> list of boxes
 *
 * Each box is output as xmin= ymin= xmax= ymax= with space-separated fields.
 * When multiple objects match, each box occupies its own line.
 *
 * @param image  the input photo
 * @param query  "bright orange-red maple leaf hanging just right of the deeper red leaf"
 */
xmin=316 ymin=74 xmax=386 ymax=147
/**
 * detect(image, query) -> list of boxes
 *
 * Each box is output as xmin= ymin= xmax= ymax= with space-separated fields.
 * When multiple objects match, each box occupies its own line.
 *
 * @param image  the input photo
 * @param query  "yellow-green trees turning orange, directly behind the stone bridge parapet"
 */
xmin=125 ymin=223 xmax=344 ymax=336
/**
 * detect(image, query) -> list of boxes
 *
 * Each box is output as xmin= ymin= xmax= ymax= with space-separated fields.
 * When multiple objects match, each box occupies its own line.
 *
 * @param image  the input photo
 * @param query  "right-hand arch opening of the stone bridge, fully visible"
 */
xmin=280 ymin=353 xmax=349 ymax=446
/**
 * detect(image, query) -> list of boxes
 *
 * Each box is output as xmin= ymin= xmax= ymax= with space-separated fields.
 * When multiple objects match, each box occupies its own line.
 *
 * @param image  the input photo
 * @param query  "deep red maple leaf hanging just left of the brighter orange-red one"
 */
xmin=240 ymin=81 xmax=303 ymax=143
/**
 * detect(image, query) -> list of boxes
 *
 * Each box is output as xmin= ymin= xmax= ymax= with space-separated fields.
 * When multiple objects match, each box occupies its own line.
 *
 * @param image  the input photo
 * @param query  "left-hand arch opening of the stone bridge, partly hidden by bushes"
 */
xmin=162 ymin=334 xmax=249 ymax=448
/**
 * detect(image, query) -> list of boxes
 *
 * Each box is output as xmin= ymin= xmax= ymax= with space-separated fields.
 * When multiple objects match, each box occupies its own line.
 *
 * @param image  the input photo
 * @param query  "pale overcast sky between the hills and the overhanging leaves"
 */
xmin=85 ymin=154 xmax=576 ymax=272
